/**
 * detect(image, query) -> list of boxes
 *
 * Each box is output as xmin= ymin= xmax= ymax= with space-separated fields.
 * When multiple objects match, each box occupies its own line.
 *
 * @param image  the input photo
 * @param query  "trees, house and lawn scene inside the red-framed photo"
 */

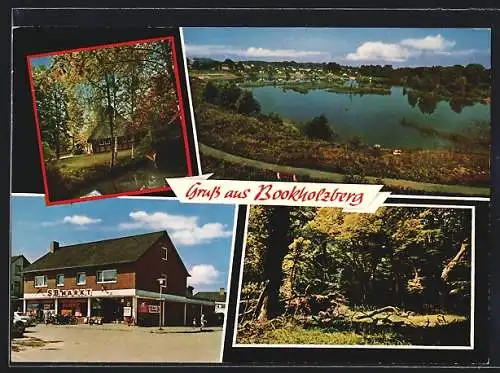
xmin=30 ymin=39 xmax=186 ymax=201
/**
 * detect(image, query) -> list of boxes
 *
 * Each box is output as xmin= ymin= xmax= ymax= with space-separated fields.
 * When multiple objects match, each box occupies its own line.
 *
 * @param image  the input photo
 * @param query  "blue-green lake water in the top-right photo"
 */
xmin=252 ymin=87 xmax=490 ymax=149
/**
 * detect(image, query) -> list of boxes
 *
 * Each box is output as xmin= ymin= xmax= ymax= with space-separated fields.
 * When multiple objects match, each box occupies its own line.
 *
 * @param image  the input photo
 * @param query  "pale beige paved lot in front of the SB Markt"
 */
xmin=11 ymin=324 xmax=222 ymax=363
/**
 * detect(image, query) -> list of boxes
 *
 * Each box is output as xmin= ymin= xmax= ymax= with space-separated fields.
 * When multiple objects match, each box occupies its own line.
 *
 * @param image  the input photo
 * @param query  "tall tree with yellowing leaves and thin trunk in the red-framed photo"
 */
xmin=53 ymin=41 xmax=178 ymax=168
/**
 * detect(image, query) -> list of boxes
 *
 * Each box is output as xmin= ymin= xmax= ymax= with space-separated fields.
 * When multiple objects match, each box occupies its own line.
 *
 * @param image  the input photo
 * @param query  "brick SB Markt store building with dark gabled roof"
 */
xmin=23 ymin=231 xmax=215 ymax=325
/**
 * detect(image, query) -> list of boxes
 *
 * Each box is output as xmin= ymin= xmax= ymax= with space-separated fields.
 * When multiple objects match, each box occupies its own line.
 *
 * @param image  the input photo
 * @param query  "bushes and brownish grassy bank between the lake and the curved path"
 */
xmin=191 ymin=79 xmax=490 ymax=193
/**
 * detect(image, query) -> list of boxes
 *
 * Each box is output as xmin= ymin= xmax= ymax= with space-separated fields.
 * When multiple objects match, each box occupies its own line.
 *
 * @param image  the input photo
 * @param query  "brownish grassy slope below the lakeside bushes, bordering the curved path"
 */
xmin=195 ymin=103 xmax=490 ymax=187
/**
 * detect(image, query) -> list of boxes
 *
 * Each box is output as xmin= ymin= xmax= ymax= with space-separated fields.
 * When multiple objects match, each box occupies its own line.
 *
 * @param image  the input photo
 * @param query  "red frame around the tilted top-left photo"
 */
xmin=26 ymin=35 xmax=194 ymax=206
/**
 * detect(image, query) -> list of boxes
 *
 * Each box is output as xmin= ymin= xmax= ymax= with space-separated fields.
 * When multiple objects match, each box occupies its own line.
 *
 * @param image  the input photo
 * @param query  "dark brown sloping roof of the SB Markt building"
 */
xmin=23 ymin=231 xmax=176 ymax=273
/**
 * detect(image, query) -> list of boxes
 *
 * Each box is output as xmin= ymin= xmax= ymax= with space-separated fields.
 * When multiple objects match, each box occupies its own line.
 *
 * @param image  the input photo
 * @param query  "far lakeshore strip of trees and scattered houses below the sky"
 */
xmin=190 ymin=59 xmax=491 ymax=108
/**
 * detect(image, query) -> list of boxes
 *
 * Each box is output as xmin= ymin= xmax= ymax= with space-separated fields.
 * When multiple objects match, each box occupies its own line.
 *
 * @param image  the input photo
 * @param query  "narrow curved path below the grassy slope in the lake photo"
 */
xmin=198 ymin=143 xmax=490 ymax=197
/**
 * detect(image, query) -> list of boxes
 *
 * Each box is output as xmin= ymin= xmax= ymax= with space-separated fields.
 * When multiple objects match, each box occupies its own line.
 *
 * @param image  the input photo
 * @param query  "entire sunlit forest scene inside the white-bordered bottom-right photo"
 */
xmin=236 ymin=206 xmax=471 ymax=346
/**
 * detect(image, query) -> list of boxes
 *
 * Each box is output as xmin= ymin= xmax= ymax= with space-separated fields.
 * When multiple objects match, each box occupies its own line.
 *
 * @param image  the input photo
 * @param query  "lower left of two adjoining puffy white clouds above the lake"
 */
xmin=346 ymin=41 xmax=410 ymax=62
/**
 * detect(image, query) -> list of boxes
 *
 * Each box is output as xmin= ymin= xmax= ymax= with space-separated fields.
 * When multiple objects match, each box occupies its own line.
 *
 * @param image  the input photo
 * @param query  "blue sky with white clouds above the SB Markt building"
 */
xmin=11 ymin=196 xmax=235 ymax=292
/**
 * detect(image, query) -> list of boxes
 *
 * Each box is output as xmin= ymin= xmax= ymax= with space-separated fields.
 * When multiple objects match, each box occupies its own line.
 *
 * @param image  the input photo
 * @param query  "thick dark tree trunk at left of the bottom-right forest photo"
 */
xmin=259 ymin=206 xmax=290 ymax=321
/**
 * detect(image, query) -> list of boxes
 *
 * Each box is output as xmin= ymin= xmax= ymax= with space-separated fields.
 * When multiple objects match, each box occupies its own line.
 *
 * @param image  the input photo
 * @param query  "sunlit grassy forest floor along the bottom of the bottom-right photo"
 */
xmin=237 ymin=312 xmax=467 ymax=345
